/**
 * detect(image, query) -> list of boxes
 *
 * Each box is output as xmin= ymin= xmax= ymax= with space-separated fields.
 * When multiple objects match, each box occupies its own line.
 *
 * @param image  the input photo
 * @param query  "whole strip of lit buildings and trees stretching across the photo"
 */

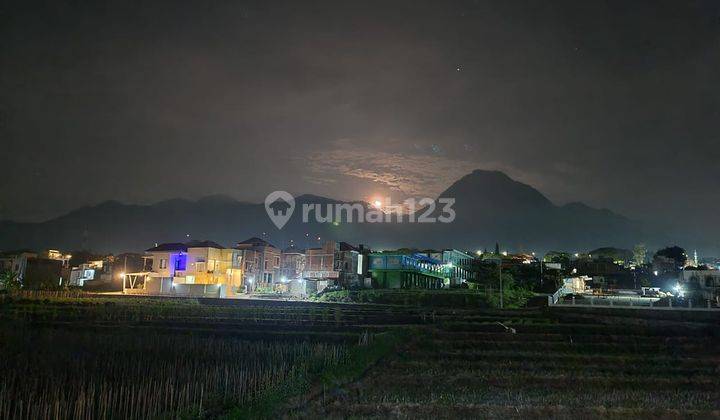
xmin=0 ymin=237 xmax=720 ymax=301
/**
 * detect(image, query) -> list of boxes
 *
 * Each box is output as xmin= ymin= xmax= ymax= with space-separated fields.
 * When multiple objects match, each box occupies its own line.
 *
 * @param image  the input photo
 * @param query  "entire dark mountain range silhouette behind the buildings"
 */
xmin=0 ymin=170 xmax=652 ymax=252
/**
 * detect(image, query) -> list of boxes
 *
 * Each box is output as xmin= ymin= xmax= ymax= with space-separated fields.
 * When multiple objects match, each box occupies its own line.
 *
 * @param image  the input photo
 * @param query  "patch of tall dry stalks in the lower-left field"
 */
xmin=0 ymin=327 xmax=346 ymax=419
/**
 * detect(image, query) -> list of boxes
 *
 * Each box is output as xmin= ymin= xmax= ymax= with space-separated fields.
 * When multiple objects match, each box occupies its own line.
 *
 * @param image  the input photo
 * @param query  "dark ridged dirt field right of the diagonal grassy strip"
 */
xmin=289 ymin=306 xmax=720 ymax=419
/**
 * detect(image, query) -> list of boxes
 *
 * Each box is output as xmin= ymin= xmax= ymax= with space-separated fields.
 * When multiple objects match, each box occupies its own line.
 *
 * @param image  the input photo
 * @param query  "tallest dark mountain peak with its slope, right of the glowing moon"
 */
xmin=420 ymin=170 xmax=646 ymax=252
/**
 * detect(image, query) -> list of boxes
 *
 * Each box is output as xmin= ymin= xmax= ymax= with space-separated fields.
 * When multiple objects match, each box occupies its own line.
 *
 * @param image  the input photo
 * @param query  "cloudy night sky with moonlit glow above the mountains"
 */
xmin=0 ymin=0 xmax=720 ymax=241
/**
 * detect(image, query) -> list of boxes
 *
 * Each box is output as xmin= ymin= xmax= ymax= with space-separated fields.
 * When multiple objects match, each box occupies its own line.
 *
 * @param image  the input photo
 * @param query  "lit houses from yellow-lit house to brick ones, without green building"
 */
xmin=123 ymin=237 xmax=366 ymax=297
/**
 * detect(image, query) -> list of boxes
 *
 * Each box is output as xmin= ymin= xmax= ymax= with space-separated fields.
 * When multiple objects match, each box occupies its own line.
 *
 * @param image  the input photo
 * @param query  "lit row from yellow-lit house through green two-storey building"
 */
xmin=114 ymin=237 xmax=484 ymax=297
